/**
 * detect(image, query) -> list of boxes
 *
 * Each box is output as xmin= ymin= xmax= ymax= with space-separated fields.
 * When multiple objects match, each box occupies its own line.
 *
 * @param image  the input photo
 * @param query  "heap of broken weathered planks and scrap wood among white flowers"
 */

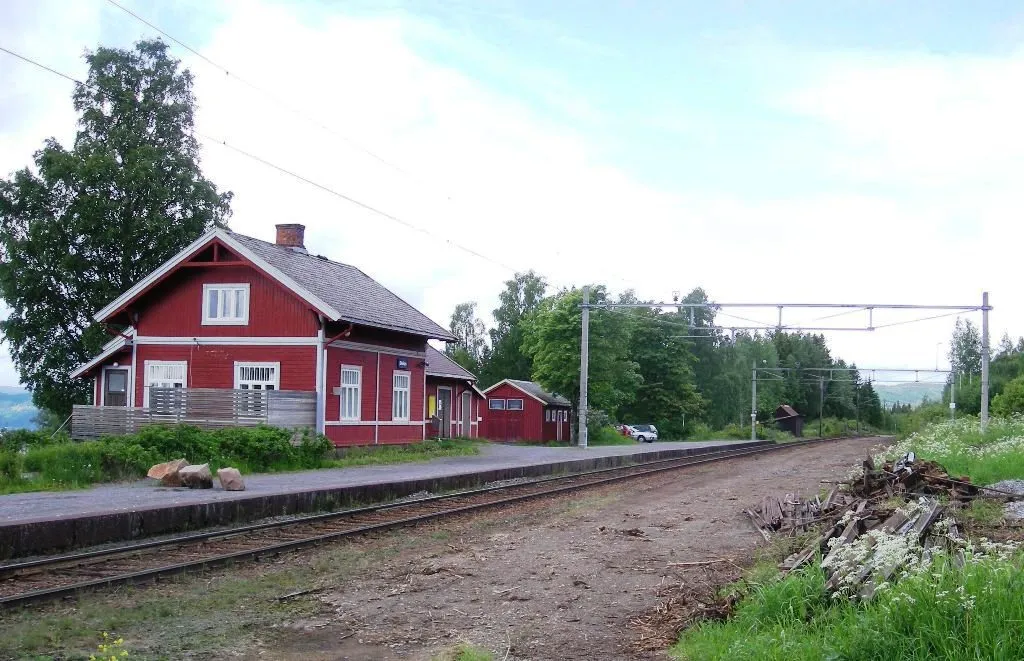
xmin=745 ymin=452 xmax=1019 ymax=600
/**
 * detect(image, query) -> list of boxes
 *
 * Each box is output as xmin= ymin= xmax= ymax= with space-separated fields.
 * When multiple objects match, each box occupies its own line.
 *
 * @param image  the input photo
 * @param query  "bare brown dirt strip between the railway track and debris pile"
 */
xmin=251 ymin=439 xmax=881 ymax=661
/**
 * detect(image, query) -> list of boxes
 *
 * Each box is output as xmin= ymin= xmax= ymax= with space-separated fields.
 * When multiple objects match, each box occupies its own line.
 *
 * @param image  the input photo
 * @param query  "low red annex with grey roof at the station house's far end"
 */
xmin=426 ymin=345 xmax=487 ymax=438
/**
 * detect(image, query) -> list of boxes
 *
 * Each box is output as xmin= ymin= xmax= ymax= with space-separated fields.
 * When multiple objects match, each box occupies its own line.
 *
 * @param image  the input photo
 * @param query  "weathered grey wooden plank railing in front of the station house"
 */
xmin=71 ymin=388 xmax=316 ymax=440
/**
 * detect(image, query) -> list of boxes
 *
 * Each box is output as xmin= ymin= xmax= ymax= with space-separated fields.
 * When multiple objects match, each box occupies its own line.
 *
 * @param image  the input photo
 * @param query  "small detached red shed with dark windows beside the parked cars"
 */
xmin=483 ymin=379 xmax=571 ymax=441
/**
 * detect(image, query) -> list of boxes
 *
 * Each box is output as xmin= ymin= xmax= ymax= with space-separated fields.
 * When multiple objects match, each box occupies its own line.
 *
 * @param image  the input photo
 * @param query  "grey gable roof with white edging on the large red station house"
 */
xmin=95 ymin=228 xmax=455 ymax=340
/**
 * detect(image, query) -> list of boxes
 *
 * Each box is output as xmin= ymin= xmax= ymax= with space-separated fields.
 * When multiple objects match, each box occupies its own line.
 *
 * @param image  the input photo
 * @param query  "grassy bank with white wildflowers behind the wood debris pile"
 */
xmin=878 ymin=415 xmax=1024 ymax=485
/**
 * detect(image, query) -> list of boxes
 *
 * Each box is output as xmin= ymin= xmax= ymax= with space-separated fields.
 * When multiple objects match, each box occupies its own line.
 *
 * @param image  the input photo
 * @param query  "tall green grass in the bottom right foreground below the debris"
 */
xmin=671 ymin=555 xmax=1024 ymax=661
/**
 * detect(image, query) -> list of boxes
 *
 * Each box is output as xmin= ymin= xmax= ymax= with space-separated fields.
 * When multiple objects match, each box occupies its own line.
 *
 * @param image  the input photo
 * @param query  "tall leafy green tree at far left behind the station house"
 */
xmin=0 ymin=41 xmax=230 ymax=413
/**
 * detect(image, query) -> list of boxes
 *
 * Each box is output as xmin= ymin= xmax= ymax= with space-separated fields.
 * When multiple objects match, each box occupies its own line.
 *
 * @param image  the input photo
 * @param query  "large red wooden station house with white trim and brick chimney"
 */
xmin=72 ymin=224 xmax=456 ymax=445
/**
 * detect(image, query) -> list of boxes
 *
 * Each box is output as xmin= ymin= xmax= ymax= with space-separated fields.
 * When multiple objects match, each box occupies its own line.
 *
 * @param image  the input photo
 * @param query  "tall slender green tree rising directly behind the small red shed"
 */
xmin=480 ymin=271 xmax=548 ymax=387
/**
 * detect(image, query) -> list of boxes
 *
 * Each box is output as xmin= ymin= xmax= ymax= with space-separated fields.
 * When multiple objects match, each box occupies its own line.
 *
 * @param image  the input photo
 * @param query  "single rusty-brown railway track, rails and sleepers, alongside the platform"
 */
xmin=0 ymin=439 xmax=880 ymax=608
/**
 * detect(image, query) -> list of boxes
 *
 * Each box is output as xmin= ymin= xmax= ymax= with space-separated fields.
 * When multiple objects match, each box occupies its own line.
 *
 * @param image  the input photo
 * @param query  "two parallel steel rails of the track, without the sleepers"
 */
xmin=0 ymin=437 xmax=880 ymax=608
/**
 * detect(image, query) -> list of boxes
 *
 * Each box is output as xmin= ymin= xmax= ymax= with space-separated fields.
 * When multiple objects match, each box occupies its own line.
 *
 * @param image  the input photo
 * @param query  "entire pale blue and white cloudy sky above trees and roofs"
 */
xmin=0 ymin=0 xmax=1024 ymax=385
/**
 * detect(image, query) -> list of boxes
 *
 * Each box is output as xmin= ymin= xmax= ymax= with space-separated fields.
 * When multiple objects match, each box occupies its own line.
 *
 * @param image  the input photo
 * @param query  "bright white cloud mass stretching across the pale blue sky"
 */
xmin=0 ymin=2 xmax=1024 ymax=388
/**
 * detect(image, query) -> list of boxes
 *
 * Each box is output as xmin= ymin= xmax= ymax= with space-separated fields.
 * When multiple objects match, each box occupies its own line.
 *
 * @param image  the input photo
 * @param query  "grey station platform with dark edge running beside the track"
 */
xmin=0 ymin=441 xmax=765 ymax=559
